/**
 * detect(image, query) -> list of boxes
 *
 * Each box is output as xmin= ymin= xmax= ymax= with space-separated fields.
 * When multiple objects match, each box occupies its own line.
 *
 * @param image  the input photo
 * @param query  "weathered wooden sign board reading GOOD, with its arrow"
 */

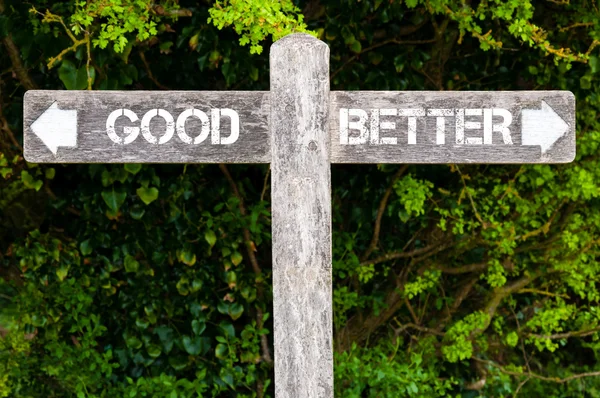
xmin=23 ymin=90 xmax=271 ymax=163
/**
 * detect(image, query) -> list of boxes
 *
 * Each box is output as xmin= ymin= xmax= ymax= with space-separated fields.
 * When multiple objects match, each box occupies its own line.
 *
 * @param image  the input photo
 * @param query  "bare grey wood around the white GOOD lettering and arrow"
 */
xmin=23 ymin=90 xmax=271 ymax=163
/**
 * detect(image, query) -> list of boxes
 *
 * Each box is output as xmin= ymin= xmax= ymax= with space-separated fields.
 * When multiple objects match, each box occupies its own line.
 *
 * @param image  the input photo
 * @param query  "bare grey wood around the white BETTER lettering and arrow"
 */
xmin=329 ymin=91 xmax=575 ymax=163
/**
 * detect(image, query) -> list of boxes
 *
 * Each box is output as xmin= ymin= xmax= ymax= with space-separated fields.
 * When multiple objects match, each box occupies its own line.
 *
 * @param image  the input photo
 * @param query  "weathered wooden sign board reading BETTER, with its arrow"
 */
xmin=329 ymin=91 xmax=575 ymax=163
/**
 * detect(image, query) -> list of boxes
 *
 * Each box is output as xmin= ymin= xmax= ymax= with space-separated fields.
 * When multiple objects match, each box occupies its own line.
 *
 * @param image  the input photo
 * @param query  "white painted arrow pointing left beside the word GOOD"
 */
xmin=31 ymin=101 xmax=77 ymax=156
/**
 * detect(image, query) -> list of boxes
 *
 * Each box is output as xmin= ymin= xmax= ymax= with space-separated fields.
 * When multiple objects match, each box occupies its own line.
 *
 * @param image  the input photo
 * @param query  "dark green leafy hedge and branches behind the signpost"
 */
xmin=0 ymin=0 xmax=600 ymax=397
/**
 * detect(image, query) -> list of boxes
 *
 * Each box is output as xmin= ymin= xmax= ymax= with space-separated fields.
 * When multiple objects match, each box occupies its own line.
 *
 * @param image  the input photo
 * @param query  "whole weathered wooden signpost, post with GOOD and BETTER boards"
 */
xmin=23 ymin=34 xmax=575 ymax=398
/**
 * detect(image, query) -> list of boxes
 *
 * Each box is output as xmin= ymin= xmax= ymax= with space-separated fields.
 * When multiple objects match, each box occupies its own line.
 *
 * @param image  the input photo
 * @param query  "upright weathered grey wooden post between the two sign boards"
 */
xmin=269 ymin=34 xmax=333 ymax=398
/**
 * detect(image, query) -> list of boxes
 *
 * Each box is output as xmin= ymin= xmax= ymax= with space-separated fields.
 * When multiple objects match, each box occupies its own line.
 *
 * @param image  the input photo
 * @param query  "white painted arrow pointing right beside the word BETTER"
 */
xmin=521 ymin=101 xmax=569 ymax=154
